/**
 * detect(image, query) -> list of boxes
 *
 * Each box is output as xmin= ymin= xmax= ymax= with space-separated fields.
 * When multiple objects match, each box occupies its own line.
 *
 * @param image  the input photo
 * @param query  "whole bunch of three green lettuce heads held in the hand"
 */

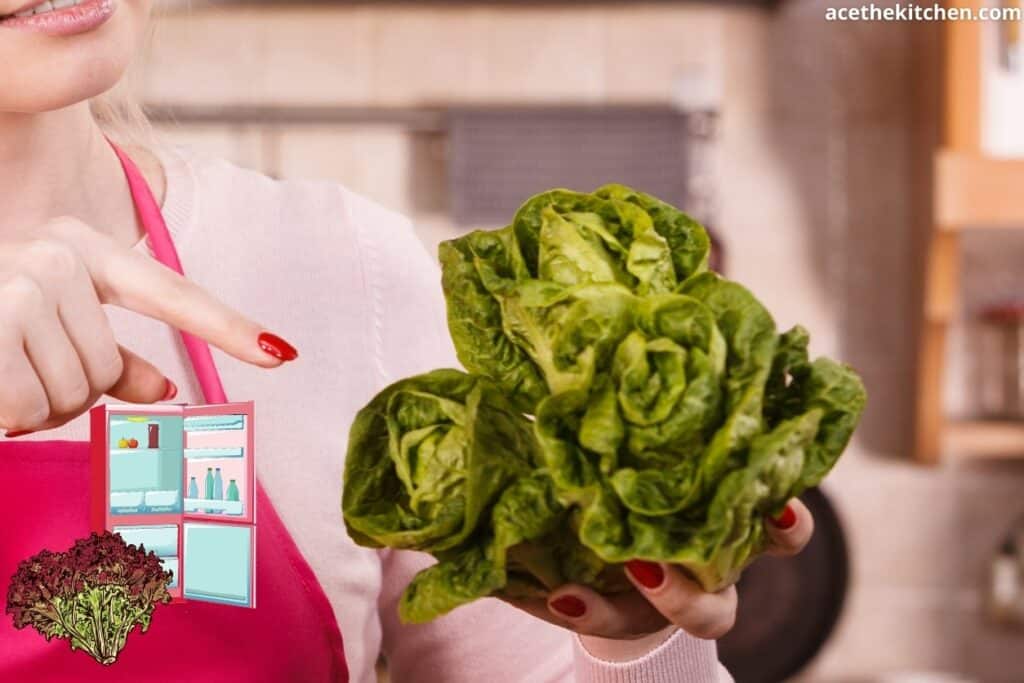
xmin=343 ymin=185 xmax=864 ymax=622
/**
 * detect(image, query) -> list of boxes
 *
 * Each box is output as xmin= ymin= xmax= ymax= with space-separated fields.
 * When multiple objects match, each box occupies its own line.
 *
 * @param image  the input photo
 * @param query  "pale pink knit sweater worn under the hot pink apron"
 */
xmin=28 ymin=150 xmax=730 ymax=683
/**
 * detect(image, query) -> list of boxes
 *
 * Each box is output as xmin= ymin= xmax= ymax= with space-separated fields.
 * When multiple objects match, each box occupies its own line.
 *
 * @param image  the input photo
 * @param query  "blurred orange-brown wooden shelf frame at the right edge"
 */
xmin=914 ymin=0 xmax=1024 ymax=463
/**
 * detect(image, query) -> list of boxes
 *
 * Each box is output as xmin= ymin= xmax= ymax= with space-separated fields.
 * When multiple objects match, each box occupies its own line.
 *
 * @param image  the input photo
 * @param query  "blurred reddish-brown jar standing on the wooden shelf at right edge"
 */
xmin=979 ymin=301 xmax=1024 ymax=420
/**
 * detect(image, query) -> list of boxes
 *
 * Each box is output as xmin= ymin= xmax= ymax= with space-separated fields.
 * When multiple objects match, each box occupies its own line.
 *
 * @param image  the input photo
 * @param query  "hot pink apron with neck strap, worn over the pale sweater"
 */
xmin=0 ymin=143 xmax=348 ymax=683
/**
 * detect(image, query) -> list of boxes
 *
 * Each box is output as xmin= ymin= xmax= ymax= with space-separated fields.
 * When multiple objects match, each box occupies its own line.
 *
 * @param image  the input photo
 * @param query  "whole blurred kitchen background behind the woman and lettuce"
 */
xmin=138 ymin=0 xmax=1024 ymax=683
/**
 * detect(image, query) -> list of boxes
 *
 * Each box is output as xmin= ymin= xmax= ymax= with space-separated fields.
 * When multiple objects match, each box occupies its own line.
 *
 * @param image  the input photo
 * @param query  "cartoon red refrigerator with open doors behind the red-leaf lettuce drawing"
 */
xmin=90 ymin=401 xmax=256 ymax=607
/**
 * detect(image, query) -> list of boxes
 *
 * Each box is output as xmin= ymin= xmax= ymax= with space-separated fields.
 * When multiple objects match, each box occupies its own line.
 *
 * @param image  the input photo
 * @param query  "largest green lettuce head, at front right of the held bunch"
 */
xmin=536 ymin=280 xmax=864 ymax=591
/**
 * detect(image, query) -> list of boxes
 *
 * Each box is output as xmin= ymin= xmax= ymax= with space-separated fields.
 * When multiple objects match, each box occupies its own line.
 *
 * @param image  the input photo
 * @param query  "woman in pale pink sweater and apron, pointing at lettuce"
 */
xmin=0 ymin=0 xmax=813 ymax=682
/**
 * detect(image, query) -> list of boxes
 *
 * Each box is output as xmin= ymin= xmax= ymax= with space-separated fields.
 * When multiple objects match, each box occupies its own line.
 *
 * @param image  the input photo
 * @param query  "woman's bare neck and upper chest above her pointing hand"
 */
xmin=0 ymin=102 xmax=164 ymax=246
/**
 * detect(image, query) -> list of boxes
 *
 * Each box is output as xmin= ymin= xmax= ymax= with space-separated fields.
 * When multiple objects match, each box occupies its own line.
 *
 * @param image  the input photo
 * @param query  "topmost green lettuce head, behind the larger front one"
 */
xmin=439 ymin=185 xmax=710 ymax=413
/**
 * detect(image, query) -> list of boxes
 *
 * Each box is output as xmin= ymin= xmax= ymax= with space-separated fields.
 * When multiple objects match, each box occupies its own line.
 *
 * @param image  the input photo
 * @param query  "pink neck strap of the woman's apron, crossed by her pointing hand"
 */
xmin=111 ymin=142 xmax=227 ymax=403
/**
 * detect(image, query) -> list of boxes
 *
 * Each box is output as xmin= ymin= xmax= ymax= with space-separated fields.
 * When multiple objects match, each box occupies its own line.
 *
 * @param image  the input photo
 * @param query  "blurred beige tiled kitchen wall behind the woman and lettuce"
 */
xmin=145 ymin=0 xmax=1024 ymax=682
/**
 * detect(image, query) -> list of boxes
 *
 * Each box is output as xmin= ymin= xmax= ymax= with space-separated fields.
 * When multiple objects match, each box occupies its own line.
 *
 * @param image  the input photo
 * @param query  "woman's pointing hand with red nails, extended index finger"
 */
xmin=0 ymin=218 xmax=297 ymax=436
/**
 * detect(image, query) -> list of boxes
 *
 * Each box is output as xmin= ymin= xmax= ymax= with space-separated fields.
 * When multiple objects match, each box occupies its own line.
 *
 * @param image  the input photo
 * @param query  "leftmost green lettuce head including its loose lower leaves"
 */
xmin=342 ymin=370 xmax=626 ymax=623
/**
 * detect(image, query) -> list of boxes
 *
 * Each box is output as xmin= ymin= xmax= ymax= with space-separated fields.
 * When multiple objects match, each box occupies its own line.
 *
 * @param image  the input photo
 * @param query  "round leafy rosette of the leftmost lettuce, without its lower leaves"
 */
xmin=343 ymin=370 xmax=536 ymax=551
